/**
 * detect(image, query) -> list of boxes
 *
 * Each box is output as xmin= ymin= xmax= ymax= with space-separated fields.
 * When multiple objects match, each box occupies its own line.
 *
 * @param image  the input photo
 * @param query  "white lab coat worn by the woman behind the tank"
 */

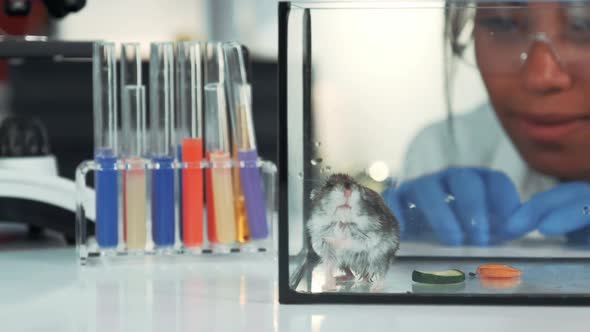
xmin=400 ymin=104 xmax=557 ymax=201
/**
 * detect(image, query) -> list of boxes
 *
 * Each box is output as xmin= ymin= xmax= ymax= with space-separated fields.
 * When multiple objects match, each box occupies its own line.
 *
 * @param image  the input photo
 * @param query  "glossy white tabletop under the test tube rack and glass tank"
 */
xmin=0 ymin=227 xmax=590 ymax=332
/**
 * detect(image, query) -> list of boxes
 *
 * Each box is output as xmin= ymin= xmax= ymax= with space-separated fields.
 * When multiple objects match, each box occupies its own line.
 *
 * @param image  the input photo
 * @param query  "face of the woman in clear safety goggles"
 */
xmin=474 ymin=3 xmax=590 ymax=180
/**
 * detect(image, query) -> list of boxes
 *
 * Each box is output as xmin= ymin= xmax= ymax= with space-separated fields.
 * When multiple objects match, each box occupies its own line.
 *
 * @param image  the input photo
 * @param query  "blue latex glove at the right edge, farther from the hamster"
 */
xmin=505 ymin=182 xmax=590 ymax=243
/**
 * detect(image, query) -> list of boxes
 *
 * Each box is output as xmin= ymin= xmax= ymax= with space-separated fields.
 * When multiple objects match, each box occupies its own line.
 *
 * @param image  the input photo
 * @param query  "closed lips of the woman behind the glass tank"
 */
xmin=516 ymin=116 xmax=590 ymax=142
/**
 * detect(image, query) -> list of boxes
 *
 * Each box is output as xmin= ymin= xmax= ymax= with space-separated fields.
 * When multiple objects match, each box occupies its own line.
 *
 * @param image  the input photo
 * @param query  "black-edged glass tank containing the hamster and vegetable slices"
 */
xmin=279 ymin=0 xmax=590 ymax=304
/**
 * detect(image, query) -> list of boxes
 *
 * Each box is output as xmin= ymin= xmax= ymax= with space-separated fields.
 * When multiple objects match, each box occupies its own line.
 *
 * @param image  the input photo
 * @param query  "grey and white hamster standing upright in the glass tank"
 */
xmin=307 ymin=174 xmax=400 ymax=282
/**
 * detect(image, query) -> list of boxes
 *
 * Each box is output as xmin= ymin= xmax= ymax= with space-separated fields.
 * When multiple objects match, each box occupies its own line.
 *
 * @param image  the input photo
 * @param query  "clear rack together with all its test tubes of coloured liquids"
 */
xmin=76 ymin=42 xmax=277 ymax=264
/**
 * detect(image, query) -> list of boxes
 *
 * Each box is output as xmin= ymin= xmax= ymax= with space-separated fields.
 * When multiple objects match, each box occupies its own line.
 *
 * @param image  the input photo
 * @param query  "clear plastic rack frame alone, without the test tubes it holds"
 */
xmin=76 ymin=160 xmax=277 ymax=265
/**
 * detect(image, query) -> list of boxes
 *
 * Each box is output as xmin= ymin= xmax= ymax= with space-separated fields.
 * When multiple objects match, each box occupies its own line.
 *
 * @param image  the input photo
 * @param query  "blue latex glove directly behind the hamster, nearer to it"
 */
xmin=383 ymin=167 xmax=520 ymax=246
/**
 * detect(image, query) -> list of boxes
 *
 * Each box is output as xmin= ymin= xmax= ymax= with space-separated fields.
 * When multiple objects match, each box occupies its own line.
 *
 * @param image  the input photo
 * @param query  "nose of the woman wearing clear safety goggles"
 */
xmin=522 ymin=41 xmax=572 ymax=95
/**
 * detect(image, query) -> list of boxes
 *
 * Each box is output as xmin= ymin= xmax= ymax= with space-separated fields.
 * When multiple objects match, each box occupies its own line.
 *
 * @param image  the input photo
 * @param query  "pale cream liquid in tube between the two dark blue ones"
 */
xmin=125 ymin=159 xmax=147 ymax=250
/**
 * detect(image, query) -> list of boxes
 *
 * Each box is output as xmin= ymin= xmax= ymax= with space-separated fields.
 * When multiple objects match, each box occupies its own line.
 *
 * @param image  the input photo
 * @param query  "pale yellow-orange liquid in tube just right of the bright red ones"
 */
xmin=209 ymin=151 xmax=237 ymax=244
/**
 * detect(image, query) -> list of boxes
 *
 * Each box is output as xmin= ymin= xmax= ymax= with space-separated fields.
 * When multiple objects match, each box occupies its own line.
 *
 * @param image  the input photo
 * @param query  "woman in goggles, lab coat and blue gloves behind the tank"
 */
xmin=383 ymin=2 xmax=590 ymax=245
